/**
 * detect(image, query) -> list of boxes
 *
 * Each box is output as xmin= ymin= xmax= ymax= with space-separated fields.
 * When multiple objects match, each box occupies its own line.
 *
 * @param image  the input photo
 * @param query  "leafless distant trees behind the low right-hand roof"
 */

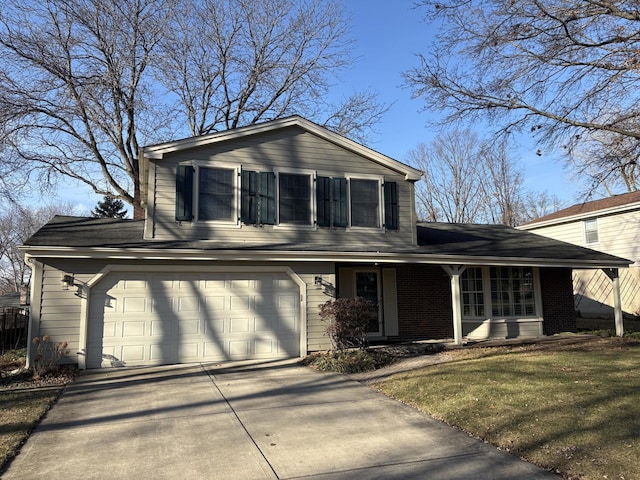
xmin=409 ymin=129 xmax=559 ymax=226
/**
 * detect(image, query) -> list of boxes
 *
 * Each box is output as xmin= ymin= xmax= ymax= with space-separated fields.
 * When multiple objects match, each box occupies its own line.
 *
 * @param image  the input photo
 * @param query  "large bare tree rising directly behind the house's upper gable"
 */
xmin=158 ymin=0 xmax=386 ymax=139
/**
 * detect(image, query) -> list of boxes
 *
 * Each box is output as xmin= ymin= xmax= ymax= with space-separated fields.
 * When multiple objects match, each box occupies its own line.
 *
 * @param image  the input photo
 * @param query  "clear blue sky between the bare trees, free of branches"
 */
xmin=337 ymin=0 xmax=579 ymax=205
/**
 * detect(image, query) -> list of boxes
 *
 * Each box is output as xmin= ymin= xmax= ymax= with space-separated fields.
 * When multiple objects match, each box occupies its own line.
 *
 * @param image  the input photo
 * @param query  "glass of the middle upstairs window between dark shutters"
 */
xmin=278 ymin=173 xmax=311 ymax=225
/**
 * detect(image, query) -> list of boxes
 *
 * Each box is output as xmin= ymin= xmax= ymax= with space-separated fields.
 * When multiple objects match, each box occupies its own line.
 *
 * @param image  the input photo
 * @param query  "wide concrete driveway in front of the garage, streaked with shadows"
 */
xmin=2 ymin=361 xmax=558 ymax=480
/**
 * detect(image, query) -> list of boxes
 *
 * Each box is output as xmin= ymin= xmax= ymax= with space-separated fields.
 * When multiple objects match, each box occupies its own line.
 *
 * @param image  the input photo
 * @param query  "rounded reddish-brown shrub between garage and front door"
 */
xmin=320 ymin=297 xmax=378 ymax=351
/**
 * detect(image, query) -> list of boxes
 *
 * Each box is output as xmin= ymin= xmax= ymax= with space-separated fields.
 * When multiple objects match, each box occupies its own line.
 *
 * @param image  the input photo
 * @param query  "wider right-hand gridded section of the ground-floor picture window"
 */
xmin=489 ymin=267 xmax=536 ymax=317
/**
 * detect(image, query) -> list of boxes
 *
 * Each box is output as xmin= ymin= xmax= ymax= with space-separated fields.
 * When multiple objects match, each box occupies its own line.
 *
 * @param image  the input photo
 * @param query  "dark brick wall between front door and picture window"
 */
xmin=396 ymin=265 xmax=453 ymax=340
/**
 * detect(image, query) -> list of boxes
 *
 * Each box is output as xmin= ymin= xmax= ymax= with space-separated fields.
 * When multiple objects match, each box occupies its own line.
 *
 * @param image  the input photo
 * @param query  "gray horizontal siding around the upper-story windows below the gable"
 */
xmin=147 ymin=128 xmax=415 ymax=245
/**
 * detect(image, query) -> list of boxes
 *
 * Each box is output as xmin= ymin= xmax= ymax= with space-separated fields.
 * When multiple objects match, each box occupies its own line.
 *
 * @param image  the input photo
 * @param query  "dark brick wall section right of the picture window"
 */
xmin=540 ymin=268 xmax=576 ymax=335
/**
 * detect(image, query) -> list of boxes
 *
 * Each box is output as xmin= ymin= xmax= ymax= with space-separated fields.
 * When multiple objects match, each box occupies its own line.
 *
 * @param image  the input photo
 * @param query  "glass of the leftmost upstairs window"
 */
xmin=198 ymin=168 xmax=234 ymax=220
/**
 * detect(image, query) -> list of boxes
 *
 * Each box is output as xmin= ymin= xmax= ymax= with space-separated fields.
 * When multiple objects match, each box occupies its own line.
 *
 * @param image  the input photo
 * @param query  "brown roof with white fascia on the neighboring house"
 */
xmin=518 ymin=191 xmax=640 ymax=230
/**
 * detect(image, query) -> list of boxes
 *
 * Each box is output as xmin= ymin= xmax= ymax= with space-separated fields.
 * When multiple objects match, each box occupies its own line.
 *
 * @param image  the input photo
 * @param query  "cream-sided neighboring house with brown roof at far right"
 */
xmin=519 ymin=192 xmax=640 ymax=318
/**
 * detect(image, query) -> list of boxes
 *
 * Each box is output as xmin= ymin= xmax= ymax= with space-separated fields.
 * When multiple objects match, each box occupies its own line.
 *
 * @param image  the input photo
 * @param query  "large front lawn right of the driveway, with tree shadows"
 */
xmin=376 ymin=337 xmax=640 ymax=480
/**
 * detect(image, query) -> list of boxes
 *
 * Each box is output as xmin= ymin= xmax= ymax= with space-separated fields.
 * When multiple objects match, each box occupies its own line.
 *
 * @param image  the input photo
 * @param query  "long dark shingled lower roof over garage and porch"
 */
xmin=22 ymin=216 xmax=631 ymax=268
